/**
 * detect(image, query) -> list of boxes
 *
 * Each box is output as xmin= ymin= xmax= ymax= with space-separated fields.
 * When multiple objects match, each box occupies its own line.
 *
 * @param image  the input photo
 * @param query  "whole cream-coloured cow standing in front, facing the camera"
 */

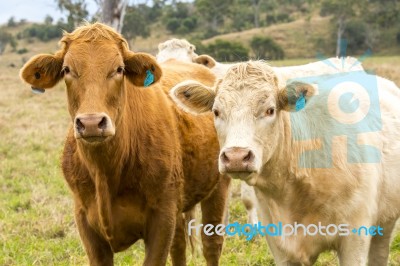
xmin=170 ymin=61 xmax=400 ymax=266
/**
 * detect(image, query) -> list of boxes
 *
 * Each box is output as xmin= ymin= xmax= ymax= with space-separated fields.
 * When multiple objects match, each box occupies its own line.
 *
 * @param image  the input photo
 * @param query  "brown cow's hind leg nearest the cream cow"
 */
xmin=201 ymin=176 xmax=230 ymax=265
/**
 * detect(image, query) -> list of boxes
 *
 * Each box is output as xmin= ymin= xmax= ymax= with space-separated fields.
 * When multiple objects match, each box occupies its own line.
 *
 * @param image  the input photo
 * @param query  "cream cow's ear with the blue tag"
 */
xmin=278 ymin=82 xmax=316 ymax=112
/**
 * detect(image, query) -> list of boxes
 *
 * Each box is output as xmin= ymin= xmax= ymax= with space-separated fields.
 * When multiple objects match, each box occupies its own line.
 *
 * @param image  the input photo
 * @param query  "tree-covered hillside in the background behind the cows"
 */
xmin=0 ymin=0 xmax=400 ymax=61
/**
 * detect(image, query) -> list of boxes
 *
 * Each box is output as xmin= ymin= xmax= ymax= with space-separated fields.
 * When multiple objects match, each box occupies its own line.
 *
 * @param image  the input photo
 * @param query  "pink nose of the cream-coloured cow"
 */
xmin=220 ymin=147 xmax=255 ymax=172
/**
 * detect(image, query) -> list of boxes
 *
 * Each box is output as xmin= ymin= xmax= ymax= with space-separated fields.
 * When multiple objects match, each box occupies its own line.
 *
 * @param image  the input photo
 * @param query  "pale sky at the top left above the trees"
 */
xmin=0 ymin=0 xmax=97 ymax=24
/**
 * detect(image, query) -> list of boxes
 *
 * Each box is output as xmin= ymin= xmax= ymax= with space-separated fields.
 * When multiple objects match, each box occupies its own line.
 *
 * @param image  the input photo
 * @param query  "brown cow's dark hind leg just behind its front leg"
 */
xmin=171 ymin=213 xmax=186 ymax=266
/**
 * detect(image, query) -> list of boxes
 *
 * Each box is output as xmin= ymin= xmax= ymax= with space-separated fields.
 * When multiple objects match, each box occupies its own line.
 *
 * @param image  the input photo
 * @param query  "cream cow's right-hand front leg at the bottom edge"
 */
xmin=338 ymin=233 xmax=371 ymax=266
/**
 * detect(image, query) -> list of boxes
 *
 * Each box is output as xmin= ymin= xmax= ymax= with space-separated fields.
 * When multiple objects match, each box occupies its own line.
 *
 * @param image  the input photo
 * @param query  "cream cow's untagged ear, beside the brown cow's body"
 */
xmin=170 ymin=80 xmax=216 ymax=114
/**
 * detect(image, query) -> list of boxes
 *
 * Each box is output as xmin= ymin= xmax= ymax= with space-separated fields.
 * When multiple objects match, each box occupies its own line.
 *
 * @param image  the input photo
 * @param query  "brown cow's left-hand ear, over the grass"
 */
xmin=20 ymin=52 xmax=64 ymax=90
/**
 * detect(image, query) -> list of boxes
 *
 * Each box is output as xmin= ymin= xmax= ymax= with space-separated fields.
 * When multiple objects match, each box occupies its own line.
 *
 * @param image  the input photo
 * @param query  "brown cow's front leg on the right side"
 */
xmin=143 ymin=206 xmax=177 ymax=266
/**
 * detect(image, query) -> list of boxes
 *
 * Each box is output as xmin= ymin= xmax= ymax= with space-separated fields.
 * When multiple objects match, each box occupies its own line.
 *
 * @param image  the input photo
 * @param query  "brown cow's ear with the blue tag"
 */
xmin=124 ymin=52 xmax=162 ymax=87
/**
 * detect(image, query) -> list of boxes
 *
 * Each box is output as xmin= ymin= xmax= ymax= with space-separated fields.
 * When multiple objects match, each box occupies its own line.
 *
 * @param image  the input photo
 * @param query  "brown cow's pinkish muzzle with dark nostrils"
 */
xmin=74 ymin=113 xmax=115 ymax=142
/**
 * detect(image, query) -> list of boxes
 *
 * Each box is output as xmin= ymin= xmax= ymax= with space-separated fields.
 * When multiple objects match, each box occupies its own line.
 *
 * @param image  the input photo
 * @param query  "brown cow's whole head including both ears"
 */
xmin=20 ymin=23 xmax=161 ymax=143
